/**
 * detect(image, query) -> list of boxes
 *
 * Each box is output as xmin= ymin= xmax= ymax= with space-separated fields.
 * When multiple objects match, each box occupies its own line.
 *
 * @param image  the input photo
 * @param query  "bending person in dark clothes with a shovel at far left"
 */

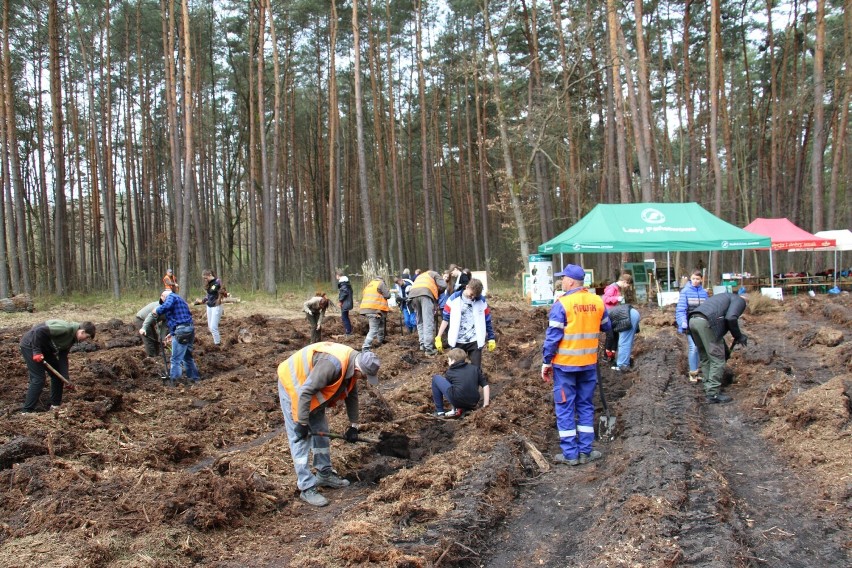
xmin=20 ymin=320 xmax=96 ymax=413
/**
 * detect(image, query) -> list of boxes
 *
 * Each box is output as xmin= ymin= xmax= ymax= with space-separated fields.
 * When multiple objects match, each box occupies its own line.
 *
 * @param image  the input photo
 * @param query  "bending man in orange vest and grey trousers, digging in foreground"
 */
xmin=278 ymin=341 xmax=381 ymax=507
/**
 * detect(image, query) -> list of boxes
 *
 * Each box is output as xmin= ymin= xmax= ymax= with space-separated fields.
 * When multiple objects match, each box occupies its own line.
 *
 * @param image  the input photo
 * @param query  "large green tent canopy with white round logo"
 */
xmin=538 ymin=203 xmax=771 ymax=254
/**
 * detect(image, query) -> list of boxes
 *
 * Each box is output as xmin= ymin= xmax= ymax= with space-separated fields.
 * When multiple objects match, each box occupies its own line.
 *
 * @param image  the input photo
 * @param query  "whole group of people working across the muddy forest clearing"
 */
xmin=15 ymin=264 xmax=748 ymax=506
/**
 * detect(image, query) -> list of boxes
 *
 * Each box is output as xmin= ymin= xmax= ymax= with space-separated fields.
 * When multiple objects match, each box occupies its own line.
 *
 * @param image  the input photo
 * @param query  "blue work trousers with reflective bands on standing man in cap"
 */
xmin=553 ymin=367 xmax=598 ymax=460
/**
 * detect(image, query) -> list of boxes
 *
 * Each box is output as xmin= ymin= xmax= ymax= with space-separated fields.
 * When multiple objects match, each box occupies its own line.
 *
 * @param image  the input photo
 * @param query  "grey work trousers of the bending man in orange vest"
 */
xmin=276 ymin=381 xmax=331 ymax=491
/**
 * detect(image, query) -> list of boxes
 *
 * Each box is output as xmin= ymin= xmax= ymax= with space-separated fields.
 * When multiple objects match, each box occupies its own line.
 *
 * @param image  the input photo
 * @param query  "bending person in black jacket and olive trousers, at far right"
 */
xmin=689 ymin=293 xmax=748 ymax=404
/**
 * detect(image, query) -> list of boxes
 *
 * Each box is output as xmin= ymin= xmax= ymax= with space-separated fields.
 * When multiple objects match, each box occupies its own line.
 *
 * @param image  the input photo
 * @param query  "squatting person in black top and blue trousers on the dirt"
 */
xmin=432 ymin=347 xmax=491 ymax=418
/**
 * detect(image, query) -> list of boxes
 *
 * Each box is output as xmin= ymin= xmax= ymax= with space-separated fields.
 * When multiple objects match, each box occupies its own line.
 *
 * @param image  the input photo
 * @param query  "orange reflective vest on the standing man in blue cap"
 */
xmin=551 ymin=290 xmax=605 ymax=367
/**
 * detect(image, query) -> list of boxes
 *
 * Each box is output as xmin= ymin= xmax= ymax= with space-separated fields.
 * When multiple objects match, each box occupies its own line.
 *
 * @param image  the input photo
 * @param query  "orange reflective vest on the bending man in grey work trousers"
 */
xmin=278 ymin=341 xmax=356 ymax=421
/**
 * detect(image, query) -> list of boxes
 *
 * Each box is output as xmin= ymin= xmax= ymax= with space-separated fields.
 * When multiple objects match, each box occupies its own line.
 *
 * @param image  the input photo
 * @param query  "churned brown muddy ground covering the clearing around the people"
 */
xmin=0 ymin=295 xmax=852 ymax=567
